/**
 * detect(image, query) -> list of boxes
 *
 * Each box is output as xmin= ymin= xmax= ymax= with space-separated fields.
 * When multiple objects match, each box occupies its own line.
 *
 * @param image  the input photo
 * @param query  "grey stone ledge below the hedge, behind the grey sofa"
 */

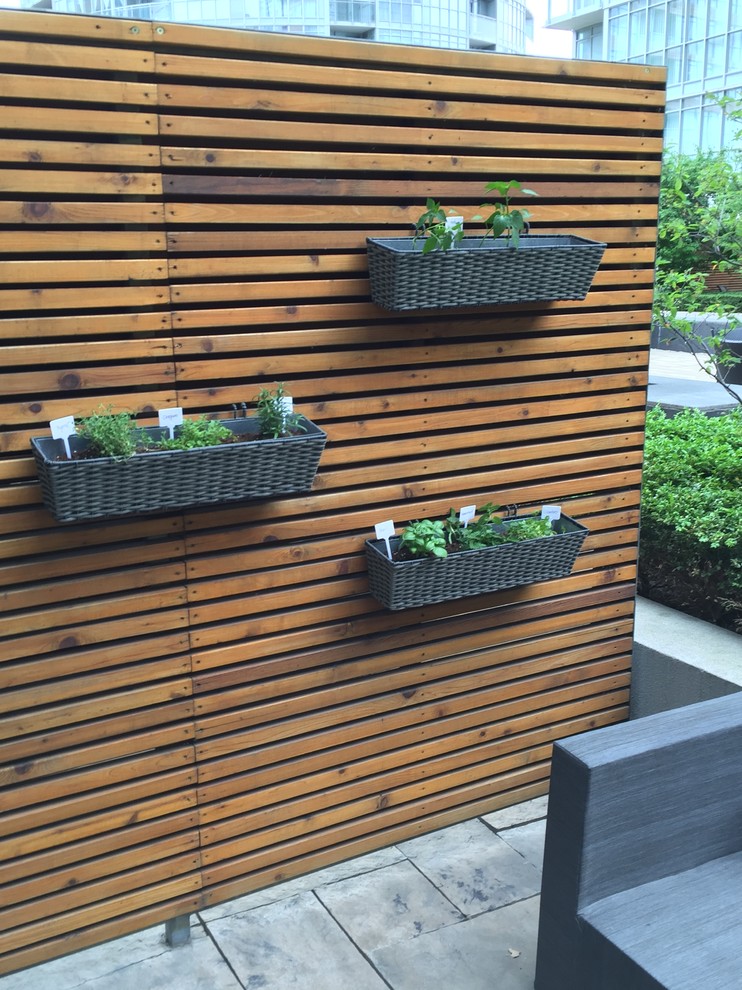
xmin=631 ymin=598 xmax=742 ymax=718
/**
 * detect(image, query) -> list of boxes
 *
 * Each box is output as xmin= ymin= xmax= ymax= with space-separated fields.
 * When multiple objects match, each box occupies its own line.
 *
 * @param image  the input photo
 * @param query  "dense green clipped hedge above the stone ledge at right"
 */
xmin=639 ymin=408 xmax=742 ymax=632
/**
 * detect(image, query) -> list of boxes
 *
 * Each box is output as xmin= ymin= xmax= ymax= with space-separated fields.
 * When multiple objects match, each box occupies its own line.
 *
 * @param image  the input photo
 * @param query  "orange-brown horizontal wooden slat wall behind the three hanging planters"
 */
xmin=0 ymin=11 xmax=664 ymax=972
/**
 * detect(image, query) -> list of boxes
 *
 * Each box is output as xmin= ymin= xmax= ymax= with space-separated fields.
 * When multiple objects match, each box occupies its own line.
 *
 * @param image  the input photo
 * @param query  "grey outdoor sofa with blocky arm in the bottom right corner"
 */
xmin=535 ymin=692 xmax=742 ymax=990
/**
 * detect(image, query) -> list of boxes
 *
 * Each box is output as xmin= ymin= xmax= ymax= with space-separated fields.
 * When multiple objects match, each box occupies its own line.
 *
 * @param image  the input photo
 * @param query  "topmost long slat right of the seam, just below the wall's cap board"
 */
xmin=156 ymin=54 xmax=664 ymax=113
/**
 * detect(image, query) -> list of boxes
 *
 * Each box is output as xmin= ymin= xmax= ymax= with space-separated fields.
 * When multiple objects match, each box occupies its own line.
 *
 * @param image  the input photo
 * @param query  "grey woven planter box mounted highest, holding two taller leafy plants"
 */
xmin=366 ymin=234 xmax=605 ymax=310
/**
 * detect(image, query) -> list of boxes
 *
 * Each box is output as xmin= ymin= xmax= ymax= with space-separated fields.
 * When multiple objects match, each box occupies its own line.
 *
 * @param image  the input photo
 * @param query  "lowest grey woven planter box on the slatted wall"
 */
xmin=366 ymin=515 xmax=588 ymax=611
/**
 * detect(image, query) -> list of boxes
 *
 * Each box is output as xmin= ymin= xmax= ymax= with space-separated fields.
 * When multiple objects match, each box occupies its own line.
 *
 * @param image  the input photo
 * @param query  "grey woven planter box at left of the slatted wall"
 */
xmin=31 ymin=417 xmax=327 ymax=522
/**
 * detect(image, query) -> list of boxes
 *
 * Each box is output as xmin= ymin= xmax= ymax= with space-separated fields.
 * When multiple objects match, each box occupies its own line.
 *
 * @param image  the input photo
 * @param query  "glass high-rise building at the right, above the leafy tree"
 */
xmin=548 ymin=0 xmax=742 ymax=152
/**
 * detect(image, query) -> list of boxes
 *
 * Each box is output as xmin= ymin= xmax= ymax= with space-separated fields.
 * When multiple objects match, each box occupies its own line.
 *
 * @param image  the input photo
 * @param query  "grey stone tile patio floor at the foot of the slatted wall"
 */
xmin=0 ymin=797 xmax=547 ymax=990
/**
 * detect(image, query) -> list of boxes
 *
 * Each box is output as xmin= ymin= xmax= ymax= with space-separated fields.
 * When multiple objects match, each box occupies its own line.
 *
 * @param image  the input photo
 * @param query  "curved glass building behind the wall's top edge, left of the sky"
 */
xmin=22 ymin=0 xmax=528 ymax=54
